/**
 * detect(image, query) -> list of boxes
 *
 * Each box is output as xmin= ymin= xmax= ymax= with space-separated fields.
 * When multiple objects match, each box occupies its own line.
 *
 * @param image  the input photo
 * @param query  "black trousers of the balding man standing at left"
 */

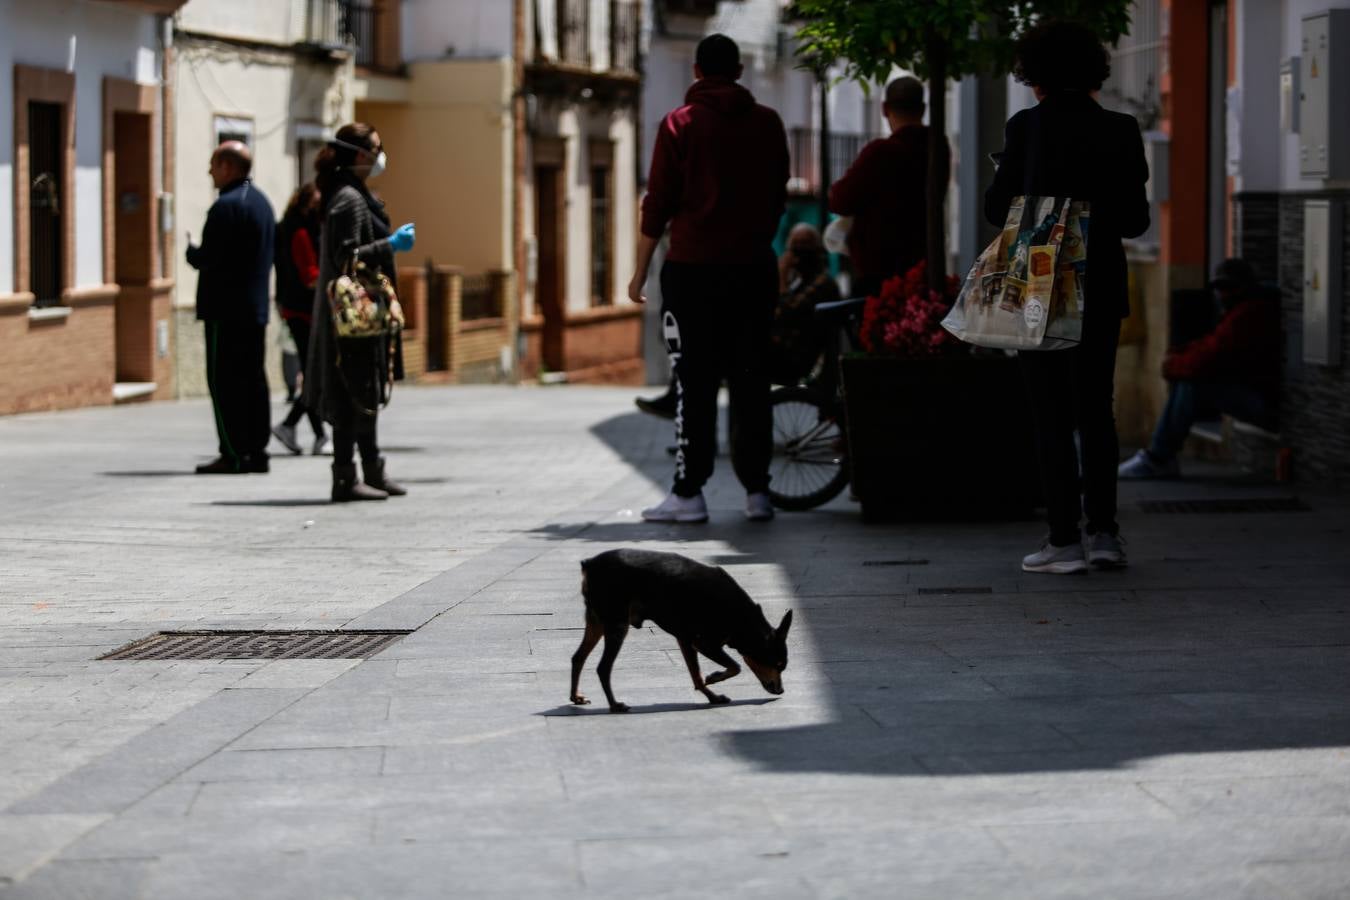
xmin=205 ymin=321 xmax=271 ymax=463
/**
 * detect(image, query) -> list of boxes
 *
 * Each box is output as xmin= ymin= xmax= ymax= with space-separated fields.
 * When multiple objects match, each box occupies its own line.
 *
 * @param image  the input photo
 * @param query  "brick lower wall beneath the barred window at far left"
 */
xmin=0 ymin=296 xmax=115 ymax=414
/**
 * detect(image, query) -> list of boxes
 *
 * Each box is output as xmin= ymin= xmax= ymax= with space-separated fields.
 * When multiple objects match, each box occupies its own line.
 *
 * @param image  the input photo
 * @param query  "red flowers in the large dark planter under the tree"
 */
xmin=859 ymin=260 xmax=961 ymax=356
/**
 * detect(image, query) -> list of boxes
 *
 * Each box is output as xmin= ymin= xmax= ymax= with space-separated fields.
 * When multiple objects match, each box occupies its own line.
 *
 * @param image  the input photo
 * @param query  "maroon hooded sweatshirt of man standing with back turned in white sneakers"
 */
xmin=643 ymin=78 xmax=788 ymax=263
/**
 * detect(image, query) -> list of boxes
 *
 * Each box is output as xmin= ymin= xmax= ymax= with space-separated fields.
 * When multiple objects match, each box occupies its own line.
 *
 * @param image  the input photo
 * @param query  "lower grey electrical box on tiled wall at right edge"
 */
xmin=1303 ymin=200 xmax=1345 ymax=366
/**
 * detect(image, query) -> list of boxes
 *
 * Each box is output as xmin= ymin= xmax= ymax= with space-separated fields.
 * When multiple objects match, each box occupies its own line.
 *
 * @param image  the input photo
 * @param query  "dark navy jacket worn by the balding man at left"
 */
xmin=188 ymin=178 xmax=277 ymax=325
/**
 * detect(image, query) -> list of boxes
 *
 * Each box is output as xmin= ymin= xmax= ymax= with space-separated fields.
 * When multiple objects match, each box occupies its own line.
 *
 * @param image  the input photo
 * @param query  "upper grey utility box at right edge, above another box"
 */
xmin=1297 ymin=9 xmax=1350 ymax=181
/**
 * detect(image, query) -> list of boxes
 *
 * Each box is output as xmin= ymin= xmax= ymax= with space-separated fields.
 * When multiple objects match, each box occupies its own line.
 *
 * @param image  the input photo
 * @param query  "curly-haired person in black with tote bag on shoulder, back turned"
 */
xmin=984 ymin=22 xmax=1149 ymax=573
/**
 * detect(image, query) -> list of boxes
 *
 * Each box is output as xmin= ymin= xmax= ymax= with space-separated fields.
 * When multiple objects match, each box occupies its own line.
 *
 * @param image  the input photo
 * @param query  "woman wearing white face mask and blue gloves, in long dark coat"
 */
xmin=304 ymin=121 xmax=414 ymax=502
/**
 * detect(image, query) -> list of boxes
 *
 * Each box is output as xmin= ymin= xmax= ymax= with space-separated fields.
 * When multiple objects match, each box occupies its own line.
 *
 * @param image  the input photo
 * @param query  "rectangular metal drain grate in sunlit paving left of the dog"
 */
xmin=99 ymin=631 xmax=410 ymax=660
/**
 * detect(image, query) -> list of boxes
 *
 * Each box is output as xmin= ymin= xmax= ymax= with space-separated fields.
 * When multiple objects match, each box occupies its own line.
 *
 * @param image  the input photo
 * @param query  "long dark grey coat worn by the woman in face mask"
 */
xmin=304 ymin=175 xmax=404 ymax=422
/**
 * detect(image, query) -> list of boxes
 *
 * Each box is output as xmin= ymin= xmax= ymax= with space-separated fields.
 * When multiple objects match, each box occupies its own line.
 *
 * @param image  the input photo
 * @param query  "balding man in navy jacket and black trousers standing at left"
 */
xmin=188 ymin=140 xmax=277 ymax=475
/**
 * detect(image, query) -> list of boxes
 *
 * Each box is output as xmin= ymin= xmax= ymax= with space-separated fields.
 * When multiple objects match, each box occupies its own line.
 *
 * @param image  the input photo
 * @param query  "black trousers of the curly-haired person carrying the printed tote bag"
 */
xmin=1018 ymin=312 xmax=1121 ymax=546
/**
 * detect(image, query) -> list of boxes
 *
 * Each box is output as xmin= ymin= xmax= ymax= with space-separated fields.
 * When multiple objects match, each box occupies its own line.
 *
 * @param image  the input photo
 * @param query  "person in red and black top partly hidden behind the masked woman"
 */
xmin=271 ymin=182 xmax=328 ymax=456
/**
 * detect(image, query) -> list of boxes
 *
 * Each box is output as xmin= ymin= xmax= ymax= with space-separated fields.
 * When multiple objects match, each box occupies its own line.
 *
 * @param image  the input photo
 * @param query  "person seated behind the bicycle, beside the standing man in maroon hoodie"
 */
xmin=770 ymin=223 xmax=840 ymax=385
